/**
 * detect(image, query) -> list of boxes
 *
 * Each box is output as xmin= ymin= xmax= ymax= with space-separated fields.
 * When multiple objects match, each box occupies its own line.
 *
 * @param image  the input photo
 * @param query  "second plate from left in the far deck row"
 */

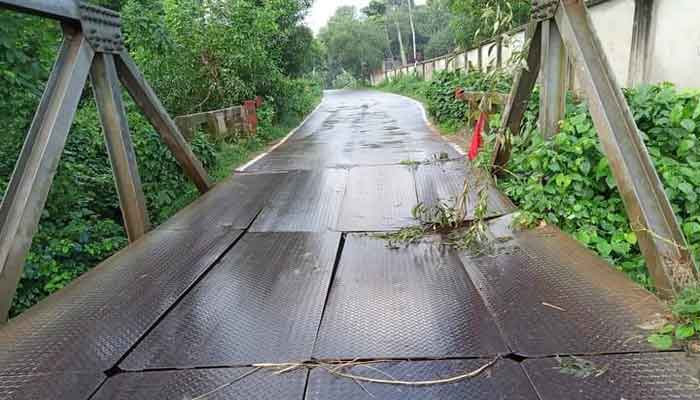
xmin=251 ymin=168 xmax=348 ymax=232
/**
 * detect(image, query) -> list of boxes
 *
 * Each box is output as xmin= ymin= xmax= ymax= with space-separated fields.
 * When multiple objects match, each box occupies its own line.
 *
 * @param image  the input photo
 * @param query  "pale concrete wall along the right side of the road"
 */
xmin=372 ymin=0 xmax=700 ymax=89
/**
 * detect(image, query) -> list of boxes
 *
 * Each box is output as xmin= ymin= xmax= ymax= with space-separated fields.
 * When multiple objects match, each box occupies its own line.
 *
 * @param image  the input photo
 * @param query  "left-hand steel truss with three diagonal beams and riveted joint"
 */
xmin=0 ymin=0 xmax=211 ymax=318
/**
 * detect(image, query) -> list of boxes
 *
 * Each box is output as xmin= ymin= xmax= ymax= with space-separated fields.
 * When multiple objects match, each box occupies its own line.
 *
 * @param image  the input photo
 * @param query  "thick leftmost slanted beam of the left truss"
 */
xmin=0 ymin=28 xmax=94 ymax=321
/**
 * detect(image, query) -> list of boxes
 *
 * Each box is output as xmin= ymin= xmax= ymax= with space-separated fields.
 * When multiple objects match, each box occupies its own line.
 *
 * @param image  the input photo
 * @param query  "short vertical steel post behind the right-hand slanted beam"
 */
xmin=540 ymin=20 xmax=568 ymax=138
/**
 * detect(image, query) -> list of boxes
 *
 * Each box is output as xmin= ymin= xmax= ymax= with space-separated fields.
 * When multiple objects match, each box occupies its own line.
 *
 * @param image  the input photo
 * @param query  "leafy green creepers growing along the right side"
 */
xmin=383 ymin=73 xmax=700 ymax=288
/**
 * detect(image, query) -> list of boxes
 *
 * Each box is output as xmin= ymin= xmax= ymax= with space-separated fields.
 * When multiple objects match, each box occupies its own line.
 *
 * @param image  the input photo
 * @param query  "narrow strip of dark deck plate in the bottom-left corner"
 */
xmin=0 ymin=371 xmax=107 ymax=400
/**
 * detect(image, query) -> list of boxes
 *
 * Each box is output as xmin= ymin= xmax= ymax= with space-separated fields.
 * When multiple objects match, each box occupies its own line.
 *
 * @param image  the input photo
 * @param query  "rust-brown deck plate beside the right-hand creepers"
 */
xmin=461 ymin=222 xmax=665 ymax=356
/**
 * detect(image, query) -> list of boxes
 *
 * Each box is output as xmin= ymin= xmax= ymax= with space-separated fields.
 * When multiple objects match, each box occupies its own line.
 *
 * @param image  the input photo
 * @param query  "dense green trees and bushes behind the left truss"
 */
xmin=0 ymin=0 xmax=320 ymax=315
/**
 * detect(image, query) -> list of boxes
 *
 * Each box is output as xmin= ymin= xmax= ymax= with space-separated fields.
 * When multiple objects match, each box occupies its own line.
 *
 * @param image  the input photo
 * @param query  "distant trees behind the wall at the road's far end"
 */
xmin=319 ymin=0 xmax=530 ymax=86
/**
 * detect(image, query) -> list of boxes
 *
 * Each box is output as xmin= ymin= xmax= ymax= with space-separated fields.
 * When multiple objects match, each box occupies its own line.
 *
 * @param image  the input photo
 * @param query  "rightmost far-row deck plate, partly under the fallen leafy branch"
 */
xmin=415 ymin=160 xmax=515 ymax=220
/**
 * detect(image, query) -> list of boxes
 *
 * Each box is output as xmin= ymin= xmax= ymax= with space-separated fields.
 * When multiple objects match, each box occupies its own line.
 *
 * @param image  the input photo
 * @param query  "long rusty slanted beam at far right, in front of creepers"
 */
xmin=555 ymin=0 xmax=697 ymax=297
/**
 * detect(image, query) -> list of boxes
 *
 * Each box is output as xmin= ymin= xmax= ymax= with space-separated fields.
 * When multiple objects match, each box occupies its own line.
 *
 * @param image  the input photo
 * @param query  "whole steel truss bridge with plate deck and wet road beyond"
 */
xmin=0 ymin=0 xmax=700 ymax=400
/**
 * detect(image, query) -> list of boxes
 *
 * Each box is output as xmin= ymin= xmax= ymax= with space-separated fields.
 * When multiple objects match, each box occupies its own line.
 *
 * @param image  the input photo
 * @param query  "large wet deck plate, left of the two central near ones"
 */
xmin=120 ymin=233 xmax=340 ymax=370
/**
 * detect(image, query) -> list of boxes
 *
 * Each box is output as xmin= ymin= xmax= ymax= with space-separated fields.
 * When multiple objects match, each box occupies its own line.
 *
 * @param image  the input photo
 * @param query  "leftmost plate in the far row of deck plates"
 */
xmin=161 ymin=173 xmax=286 ymax=229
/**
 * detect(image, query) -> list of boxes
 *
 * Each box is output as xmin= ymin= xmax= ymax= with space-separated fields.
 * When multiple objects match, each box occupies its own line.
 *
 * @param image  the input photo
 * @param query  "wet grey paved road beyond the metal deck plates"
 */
xmin=247 ymin=91 xmax=459 ymax=171
